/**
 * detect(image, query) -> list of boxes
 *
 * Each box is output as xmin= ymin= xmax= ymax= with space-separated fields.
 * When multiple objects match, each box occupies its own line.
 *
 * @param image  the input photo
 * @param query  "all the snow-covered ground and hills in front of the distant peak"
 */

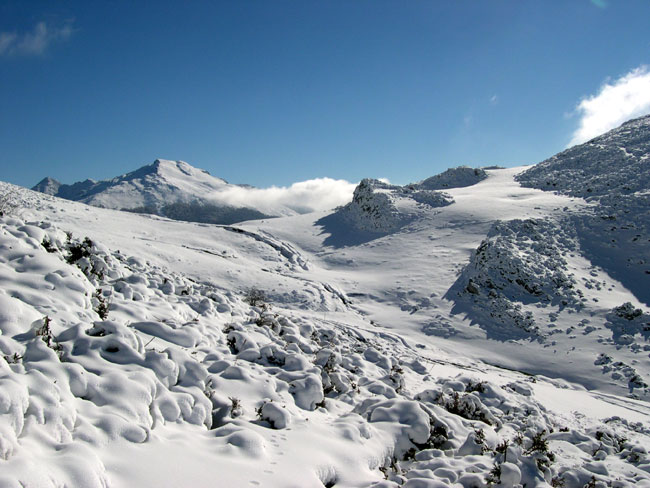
xmin=0 ymin=119 xmax=650 ymax=488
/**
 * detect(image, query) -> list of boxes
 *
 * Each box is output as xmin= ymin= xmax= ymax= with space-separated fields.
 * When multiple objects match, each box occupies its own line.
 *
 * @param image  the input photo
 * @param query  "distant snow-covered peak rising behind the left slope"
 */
xmin=32 ymin=159 xmax=296 ymax=224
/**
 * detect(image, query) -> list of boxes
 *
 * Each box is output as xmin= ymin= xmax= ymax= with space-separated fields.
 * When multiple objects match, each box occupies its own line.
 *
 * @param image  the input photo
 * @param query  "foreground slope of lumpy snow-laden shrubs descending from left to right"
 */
xmin=0 ymin=207 xmax=650 ymax=487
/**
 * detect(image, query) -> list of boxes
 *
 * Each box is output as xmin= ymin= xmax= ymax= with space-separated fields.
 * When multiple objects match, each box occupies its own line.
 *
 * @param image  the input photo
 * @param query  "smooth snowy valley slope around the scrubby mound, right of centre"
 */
xmin=252 ymin=168 xmax=650 ymax=398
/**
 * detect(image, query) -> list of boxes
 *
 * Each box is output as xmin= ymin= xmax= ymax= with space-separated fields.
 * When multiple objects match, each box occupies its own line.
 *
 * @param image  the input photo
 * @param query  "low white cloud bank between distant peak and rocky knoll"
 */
xmin=210 ymin=178 xmax=356 ymax=213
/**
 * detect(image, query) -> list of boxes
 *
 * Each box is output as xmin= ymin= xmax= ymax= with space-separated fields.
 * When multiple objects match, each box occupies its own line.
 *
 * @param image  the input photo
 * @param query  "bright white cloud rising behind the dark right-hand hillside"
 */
xmin=569 ymin=66 xmax=650 ymax=146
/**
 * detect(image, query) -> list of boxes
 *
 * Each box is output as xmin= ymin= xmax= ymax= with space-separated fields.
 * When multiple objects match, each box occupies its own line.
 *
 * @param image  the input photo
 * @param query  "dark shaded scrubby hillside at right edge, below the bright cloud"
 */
xmin=517 ymin=115 xmax=650 ymax=306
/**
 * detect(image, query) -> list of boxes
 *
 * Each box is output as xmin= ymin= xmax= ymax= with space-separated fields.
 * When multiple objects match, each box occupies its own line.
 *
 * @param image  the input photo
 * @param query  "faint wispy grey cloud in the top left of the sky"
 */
xmin=0 ymin=22 xmax=72 ymax=56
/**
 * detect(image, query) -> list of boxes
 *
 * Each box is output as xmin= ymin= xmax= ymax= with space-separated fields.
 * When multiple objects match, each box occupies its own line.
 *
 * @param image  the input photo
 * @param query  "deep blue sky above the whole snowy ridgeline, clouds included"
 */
xmin=0 ymin=0 xmax=650 ymax=187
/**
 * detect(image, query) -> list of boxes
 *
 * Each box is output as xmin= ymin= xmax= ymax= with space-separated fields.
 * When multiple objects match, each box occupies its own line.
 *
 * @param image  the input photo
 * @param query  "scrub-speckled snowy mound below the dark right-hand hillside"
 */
xmin=447 ymin=219 xmax=581 ymax=339
